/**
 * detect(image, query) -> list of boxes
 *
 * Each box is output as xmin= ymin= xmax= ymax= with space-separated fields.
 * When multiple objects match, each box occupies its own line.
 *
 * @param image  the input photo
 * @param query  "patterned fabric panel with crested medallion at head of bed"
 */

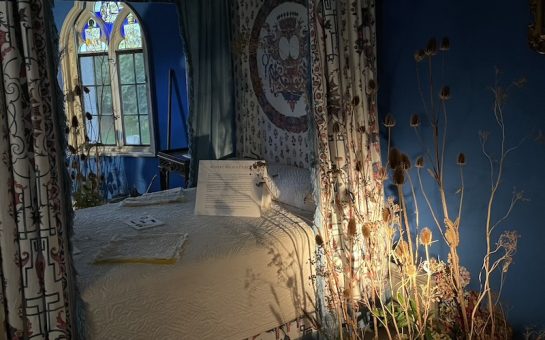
xmin=232 ymin=0 xmax=312 ymax=168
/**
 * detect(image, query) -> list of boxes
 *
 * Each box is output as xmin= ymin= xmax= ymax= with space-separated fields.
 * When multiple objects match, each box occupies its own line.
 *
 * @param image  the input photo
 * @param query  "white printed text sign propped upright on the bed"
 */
xmin=195 ymin=160 xmax=271 ymax=217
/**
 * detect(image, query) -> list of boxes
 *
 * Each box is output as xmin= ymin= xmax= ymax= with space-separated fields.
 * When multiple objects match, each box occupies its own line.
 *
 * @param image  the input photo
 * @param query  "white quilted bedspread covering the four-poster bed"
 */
xmin=74 ymin=190 xmax=314 ymax=340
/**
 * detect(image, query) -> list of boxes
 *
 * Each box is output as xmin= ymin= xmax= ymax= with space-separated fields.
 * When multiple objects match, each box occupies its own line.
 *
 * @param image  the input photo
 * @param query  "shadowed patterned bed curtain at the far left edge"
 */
xmin=0 ymin=0 xmax=72 ymax=339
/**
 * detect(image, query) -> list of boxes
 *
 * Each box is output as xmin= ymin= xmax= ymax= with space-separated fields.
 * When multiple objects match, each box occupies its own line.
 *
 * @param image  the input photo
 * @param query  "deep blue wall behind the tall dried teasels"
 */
xmin=377 ymin=0 xmax=545 ymax=335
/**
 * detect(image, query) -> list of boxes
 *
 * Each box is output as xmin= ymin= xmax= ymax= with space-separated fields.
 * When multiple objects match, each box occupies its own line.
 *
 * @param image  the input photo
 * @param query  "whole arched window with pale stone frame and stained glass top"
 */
xmin=60 ymin=1 xmax=154 ymax=155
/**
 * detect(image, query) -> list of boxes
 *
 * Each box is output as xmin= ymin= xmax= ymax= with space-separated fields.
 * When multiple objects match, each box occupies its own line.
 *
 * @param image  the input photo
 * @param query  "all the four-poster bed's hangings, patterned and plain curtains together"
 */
xmin=0 ymin=0 xmax=383 ymax=339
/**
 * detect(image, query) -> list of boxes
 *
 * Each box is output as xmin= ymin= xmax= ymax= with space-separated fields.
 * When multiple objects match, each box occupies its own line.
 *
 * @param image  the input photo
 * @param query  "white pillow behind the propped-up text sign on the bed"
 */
xmin=267 ymin=164 xmax=316 ymax=212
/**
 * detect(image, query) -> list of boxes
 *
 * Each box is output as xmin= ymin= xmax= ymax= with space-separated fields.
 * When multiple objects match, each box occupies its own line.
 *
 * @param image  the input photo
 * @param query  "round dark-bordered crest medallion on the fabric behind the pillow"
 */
xmin=249 ymin=0 xmax=309 ymax=133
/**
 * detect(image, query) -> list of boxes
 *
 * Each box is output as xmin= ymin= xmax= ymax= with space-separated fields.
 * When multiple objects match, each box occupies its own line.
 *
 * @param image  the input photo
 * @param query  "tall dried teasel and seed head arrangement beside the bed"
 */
xmin=315 ymin=38 xmax=525 ymax=339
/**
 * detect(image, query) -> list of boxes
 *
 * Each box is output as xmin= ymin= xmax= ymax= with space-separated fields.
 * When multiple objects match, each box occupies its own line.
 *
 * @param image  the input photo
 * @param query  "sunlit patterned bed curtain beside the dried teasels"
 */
xmin=309 ymin=0 xmax=384 ymax=299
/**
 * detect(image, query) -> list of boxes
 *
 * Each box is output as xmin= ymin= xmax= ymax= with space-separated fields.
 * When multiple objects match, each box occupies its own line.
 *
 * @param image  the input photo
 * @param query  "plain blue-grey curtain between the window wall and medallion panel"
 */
xmin=177 ymin=0 xmax=235 ymax=186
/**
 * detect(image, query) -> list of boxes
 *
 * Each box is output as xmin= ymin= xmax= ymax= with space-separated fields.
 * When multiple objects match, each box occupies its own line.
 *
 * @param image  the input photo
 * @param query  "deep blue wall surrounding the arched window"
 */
xmin=53 ymin=0 xmax=189 ymax=193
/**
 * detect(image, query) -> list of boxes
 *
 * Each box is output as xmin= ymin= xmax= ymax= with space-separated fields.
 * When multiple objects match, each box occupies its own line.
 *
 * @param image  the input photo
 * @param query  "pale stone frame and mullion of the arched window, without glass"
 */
xmin=59 ymin=1 xmax=156 ymax=157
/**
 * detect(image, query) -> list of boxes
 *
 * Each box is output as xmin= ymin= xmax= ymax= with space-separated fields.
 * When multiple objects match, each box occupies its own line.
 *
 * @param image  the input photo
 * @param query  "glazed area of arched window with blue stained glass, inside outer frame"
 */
xmin=70 ymin=1 xmax=152 ymax=149
